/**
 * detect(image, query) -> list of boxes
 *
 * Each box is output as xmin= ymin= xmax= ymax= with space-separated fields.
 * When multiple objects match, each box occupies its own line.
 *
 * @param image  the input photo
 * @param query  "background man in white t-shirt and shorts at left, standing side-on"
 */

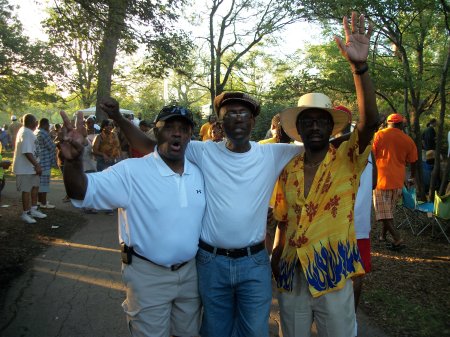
xmin=13 ymin=114 xmax=47 ymax=224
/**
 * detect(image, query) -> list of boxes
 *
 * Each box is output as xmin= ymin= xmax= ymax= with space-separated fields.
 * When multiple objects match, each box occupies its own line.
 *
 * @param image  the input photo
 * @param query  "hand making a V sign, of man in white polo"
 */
xmin=58 ymin=111 xmax=87 ymax=160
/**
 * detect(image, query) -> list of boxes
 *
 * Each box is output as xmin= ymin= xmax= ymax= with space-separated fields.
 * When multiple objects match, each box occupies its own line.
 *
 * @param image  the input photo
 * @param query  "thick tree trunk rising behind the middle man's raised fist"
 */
xmin=95 ymin=0 xmax=129 ymax=121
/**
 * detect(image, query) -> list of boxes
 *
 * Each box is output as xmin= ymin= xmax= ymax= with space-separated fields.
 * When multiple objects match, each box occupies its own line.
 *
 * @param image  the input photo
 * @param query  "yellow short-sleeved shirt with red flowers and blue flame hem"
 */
xmin=274 ymin=130 xmax=371 ymax=297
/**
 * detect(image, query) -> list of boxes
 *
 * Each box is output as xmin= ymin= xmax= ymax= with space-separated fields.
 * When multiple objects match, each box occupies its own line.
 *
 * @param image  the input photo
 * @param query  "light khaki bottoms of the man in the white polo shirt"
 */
xmin=122 ymin=256 xmax=201 ymax=337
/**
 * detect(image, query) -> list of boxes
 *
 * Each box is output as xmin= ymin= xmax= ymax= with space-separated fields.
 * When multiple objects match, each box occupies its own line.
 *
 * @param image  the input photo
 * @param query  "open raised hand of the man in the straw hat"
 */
xmin=334 ymin=12 xmax=373 ymax=64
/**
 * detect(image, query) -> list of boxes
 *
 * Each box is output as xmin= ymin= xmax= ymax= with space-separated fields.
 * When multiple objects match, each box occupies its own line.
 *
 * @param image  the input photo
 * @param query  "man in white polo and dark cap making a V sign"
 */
xmin=59 ymin=104 xmax=205 ymax=337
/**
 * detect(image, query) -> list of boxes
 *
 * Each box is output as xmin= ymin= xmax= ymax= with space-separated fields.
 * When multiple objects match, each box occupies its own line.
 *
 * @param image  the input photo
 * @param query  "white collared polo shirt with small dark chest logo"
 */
xmin=72 ymin=150 xmax=205 ymax=266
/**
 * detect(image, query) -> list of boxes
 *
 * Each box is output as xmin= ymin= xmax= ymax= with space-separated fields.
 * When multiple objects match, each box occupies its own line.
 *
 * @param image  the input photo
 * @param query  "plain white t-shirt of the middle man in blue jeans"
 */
xmin=186 ymin=141 xmax=303 ymax=248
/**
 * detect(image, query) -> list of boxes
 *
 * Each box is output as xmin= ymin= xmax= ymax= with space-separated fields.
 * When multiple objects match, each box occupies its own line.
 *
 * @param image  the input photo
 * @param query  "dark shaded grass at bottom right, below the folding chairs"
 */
xmin=361 ymin=228 xmax=450 ymax=337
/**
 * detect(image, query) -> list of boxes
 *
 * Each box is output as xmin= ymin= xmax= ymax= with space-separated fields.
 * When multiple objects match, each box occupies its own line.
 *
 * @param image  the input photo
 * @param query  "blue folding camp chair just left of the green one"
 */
xmin=397 ymin=186 xmax=434 ymax=235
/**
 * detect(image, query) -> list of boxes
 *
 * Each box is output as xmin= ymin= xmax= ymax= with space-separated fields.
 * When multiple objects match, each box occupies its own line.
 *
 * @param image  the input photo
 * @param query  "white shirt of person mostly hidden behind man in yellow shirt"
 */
xmin=355 ymin=156 xmax=373 ymax=239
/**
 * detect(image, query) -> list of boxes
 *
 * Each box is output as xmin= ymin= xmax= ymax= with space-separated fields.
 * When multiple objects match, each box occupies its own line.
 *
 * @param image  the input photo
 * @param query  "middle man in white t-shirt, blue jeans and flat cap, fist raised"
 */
xmin=103 ymin=92 xmax=302 ymax=337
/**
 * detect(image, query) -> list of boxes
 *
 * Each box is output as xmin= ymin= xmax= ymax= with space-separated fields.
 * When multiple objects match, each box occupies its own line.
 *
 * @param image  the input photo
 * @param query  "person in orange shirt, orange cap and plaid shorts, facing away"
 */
xmin=372 ymin=114 xmax=418 ymax=250
